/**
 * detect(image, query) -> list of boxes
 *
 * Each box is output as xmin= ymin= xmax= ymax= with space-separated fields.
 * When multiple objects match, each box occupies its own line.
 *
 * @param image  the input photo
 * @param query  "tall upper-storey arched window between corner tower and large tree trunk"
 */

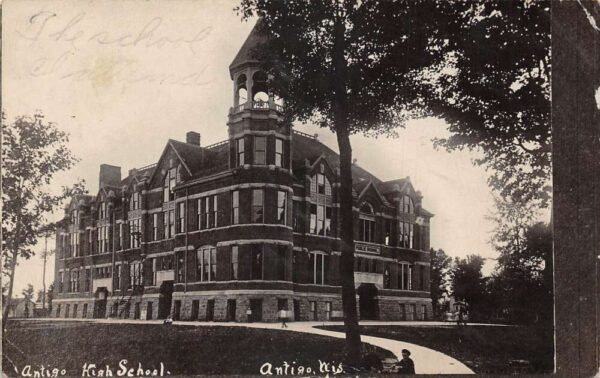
xmin=310 ymin=173 xmax=333 ymax=236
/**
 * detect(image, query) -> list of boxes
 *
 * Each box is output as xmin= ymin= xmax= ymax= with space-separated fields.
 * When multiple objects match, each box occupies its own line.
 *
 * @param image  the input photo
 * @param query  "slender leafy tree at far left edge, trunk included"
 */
xmin=2 ymin=113 xmax=83 ymax=328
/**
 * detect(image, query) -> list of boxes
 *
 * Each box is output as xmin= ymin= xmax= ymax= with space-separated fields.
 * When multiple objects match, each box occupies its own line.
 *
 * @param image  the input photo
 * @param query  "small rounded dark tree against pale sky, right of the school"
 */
xmin=450 ymin=255 xmax=486 ymax=314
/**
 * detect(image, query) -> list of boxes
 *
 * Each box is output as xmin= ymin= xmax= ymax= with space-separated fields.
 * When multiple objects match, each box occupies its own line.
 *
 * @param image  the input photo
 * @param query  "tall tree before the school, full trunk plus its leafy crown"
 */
xmin=239 ymin=0 xmax=466 ymax=361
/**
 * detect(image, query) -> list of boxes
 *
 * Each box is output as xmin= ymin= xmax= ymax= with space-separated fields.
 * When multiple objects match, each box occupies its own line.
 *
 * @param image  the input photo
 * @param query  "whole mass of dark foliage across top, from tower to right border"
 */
xmin=238 ymin=0 xmax=550 ymax=206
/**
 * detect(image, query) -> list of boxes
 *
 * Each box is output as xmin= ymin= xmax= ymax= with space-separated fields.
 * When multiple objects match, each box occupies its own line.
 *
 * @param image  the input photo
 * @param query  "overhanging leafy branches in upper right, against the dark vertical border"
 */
xmin=429 ymin=0 xmax=551 ymax=207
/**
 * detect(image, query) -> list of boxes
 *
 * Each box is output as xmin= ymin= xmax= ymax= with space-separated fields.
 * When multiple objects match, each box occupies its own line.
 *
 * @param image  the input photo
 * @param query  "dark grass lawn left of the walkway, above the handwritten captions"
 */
xmin=3 ymin=320 xmax=391 ymax=376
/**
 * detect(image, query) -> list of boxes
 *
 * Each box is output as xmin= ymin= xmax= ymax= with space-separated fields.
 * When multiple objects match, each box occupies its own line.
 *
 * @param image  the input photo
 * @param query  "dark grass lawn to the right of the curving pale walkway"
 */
xmin=319 ymin=325 xmax=554 ymax=374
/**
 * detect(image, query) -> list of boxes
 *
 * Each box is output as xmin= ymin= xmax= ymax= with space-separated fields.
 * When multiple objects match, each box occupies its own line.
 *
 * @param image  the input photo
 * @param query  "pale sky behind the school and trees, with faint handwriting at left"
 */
xmin=2 ymin=0 xmax=524 ymax=295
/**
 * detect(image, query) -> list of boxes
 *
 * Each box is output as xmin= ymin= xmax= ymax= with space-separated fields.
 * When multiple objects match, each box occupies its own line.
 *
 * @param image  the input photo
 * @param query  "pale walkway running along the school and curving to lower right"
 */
xmin=32 ymin=318 xmax=475 ymax=374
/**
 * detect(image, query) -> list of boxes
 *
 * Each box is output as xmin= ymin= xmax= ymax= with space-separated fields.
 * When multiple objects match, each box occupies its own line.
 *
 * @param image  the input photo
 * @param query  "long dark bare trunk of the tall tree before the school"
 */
xmin=333 ymin=14 xmax=361 ymax=364
